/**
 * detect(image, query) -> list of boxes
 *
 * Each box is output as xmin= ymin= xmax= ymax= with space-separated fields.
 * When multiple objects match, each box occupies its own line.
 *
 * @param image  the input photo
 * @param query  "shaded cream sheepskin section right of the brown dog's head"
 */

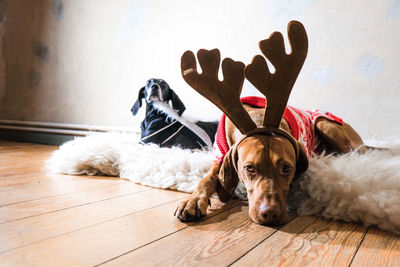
xmin=288 ymin=142 xmax=400 ymax=233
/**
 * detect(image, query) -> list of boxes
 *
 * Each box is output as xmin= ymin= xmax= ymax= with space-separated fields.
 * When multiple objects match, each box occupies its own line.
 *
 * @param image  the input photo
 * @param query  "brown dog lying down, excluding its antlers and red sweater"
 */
xmin=176 ymin=106 xmax=365 ymax=224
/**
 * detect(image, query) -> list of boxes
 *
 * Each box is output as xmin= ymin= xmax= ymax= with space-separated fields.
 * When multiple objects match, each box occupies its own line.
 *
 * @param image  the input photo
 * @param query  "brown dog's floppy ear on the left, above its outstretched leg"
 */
xmin=217 ymin=145 xmax=239 ymax=202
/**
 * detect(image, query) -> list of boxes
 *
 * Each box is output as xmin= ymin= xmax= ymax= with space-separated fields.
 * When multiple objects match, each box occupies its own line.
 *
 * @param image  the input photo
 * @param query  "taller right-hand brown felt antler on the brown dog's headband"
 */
xmin=245 ymin=21 xmax=308 ymax=128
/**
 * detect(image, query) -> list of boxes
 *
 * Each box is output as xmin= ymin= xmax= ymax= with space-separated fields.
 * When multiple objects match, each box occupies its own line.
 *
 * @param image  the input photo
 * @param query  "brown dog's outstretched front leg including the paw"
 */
xmin=174 ymin=161 xmax=220 ymax=222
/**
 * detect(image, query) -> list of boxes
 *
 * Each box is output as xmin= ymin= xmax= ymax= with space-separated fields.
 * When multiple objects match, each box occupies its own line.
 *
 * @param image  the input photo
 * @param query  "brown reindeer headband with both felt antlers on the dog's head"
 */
xmin=181 ymin=21 xmax=308 ymax=159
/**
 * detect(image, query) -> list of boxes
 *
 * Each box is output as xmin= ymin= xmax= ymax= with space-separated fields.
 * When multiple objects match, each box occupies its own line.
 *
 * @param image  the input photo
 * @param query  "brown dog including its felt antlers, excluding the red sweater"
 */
xmin=175 ymin=22 xmax=365 ymax=224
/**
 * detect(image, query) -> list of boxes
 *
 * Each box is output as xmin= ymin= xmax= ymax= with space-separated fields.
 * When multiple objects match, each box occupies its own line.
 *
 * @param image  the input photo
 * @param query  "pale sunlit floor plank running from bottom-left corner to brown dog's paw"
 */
xmin=0 ymin=200 xmax=238 ymax=266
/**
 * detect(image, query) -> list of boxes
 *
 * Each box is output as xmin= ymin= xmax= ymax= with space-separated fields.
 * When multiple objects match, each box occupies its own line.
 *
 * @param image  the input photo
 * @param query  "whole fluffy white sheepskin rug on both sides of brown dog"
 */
xmin=47 ymin=133 xmax=400 ymax=234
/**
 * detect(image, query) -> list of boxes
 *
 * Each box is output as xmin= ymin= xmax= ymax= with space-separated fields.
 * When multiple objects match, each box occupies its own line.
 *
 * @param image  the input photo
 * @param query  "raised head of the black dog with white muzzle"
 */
xmin=131 ymin=79 xmax=186 ymax=116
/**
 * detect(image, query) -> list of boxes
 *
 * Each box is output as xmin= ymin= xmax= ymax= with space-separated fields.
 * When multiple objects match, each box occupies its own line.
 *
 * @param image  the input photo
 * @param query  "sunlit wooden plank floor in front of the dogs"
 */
xmin=0 ymin=141 xmax=400 ymax=266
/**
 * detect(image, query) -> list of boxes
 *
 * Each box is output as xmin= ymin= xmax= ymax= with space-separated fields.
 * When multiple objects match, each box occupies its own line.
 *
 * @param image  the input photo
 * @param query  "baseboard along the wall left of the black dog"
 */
xmin=0 ymin=120 xmax=138 ymax=145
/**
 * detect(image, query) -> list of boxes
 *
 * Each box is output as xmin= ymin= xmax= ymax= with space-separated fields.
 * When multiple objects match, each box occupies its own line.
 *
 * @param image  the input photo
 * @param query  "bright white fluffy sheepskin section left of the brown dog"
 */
xmin=46 ymin=133 xmax=213 ymax=192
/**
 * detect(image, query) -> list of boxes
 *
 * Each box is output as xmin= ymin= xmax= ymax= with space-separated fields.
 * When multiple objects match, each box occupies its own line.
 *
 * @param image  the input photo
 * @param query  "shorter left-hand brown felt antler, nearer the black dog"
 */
xmin=181 ymin=49 xmax=257 ymax=134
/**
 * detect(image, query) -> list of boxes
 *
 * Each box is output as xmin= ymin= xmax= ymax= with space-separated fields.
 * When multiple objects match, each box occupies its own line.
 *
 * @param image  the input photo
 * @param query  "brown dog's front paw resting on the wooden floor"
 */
xmin=174 ymin=197 xmax=211 ymax=222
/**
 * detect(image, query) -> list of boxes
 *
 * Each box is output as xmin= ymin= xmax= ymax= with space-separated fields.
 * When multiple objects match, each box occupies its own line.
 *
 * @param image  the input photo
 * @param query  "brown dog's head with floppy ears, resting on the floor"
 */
xmin=218 ymin=134 xmax=308 ymax=225
